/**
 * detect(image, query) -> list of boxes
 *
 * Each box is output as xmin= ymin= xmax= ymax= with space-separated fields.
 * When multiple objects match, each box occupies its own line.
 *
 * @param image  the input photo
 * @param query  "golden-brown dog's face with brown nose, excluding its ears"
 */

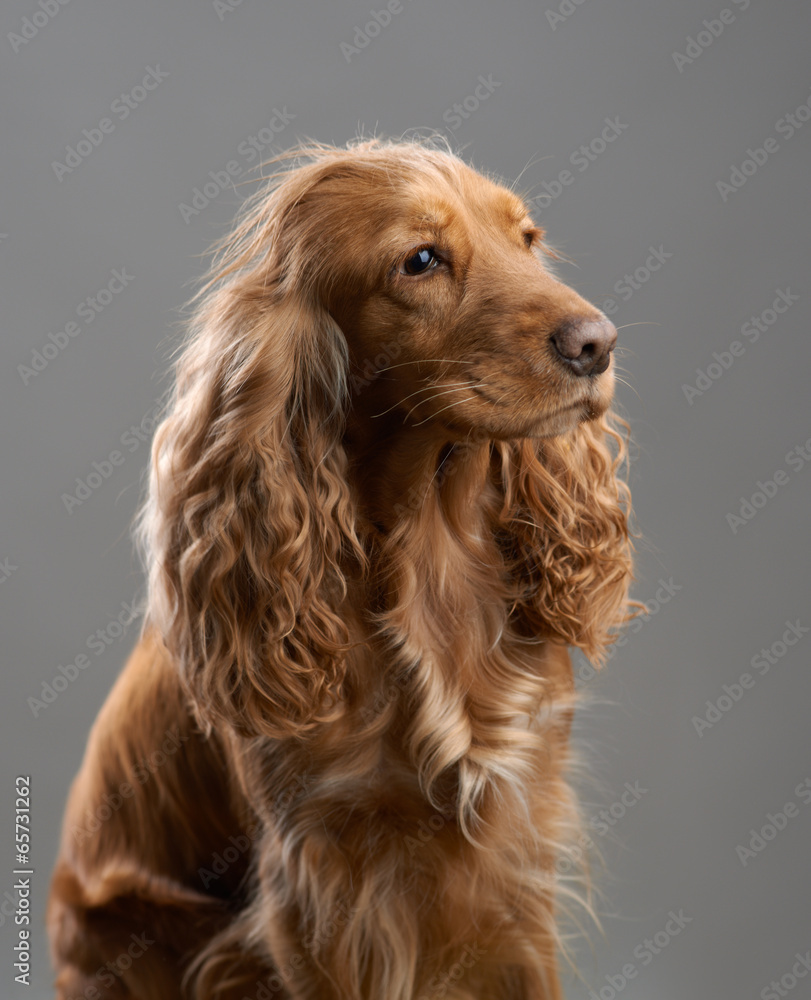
xmin=302 ymin=153 xmax=616 ymax=439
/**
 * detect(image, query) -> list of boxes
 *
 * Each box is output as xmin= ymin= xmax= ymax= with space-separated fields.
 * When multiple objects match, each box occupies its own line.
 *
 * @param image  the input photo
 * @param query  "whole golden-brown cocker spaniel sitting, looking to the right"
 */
xmin=49 ymin=140 xmax=631 ymax=1000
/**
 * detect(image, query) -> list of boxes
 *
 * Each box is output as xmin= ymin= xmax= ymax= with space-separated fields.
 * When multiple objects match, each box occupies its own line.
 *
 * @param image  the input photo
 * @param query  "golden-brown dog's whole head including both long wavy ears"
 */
xmin=141 ymin=141 xmax=630 ymax=733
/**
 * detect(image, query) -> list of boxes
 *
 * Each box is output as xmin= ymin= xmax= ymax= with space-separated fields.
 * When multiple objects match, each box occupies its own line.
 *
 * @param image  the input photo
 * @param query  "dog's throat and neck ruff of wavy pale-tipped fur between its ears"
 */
xmin=336 ymin=408 xmax=560 ymax=836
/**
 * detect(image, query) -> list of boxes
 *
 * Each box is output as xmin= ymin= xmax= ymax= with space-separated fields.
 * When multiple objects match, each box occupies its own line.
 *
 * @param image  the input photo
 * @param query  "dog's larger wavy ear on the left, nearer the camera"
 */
xmin=138 ymin=170 xmax=363 ymax=736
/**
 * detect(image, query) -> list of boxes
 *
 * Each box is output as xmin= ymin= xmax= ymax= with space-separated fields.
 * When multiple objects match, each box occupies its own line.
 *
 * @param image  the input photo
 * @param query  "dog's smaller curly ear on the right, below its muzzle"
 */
xmin=499 ymin=416 xmax=633 ymax=664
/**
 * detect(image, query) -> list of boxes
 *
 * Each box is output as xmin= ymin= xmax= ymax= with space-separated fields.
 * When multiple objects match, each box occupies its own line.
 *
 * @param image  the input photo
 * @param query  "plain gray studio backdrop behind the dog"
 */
xmin=0 ymin=0 xmax=811 ymax=1000
